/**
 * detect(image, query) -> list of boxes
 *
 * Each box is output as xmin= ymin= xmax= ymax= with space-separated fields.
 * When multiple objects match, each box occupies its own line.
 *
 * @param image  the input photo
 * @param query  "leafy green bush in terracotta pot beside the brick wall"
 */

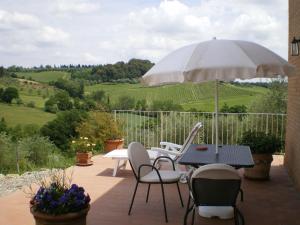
xmin=239 ymin=131 xmax=282 ymax=180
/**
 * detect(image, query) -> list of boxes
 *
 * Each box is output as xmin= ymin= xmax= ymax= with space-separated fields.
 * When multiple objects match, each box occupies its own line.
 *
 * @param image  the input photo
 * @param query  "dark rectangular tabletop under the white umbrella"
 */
xmin=178 ymin=144 xmax=254 ymax=168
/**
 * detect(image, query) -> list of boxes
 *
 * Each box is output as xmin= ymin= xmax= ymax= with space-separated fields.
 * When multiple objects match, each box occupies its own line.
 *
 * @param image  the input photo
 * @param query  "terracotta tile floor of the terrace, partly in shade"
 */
xmin=0 ymin=156 xmax=300 ymax=225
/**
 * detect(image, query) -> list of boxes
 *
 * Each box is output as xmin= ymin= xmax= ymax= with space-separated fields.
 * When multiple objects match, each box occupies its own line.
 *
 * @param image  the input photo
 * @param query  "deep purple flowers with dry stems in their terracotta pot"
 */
xmin=30 ymin=172 xmax=90 ymax=225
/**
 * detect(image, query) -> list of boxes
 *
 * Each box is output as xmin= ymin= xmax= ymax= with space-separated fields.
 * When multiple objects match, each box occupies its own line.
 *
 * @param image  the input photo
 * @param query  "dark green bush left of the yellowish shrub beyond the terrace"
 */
xmin=41 ymin=110 xmax=87 ymax=151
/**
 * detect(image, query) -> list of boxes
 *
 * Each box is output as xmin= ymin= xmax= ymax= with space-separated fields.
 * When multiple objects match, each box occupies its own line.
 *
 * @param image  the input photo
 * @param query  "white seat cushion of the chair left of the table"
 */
xmin=141 ymin=170 xmax=181 ymax=183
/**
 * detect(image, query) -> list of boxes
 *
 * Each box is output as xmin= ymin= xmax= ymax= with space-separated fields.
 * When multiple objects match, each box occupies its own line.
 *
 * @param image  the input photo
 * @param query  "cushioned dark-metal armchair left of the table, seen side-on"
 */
xmin=128 ymin=142 xmax=183 ymax=222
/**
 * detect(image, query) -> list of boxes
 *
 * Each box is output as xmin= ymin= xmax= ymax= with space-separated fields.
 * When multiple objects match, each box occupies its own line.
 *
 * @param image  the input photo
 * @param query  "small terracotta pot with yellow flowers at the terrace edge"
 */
xmin=72 ymin=137 xmax=95 ymax=166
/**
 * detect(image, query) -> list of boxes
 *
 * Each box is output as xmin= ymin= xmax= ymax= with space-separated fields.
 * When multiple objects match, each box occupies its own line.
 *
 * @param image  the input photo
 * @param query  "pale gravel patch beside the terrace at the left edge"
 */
xmin=0 ymin=170 xmax=51 ymax=197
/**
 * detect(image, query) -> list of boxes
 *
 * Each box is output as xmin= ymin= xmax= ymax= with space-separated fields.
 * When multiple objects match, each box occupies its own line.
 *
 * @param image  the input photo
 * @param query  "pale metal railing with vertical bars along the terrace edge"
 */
xmin=113 ymin=110 xmax=286 ymax=152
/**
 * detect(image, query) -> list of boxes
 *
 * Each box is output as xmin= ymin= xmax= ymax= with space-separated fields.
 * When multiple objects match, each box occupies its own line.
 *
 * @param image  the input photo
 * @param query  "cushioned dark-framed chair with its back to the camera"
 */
xmin=184 ymin=164 xmax=244 ymax=225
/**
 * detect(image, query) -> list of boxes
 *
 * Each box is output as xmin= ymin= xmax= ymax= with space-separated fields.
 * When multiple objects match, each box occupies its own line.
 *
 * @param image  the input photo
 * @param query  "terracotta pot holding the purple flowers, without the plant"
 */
xmin=30 ymin=206 xmax=90 ymax=225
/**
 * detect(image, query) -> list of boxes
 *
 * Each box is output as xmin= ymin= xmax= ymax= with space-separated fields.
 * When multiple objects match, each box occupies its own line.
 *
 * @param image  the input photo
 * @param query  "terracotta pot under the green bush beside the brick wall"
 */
xmin=244 ymin=154 xmax=273 ymax=180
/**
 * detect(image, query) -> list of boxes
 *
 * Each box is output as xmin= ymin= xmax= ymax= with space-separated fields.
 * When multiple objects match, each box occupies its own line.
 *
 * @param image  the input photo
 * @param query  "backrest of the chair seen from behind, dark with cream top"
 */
xmin=190 ymin=164 xmax=241 ymax=206
